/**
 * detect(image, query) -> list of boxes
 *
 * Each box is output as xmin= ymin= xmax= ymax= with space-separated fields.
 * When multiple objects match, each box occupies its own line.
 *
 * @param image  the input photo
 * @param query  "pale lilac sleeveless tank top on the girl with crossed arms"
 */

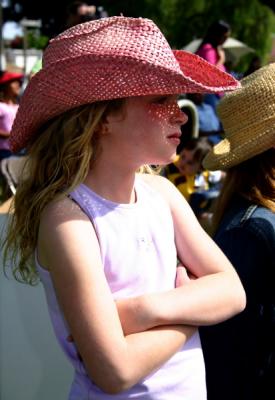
xmin=36 ymin=176 xmax=206 ymax=400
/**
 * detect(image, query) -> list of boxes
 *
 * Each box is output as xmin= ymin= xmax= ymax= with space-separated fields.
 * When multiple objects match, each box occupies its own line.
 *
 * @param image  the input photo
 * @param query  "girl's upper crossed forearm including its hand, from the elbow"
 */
xmin=117 ymin=272 xmax=245 ymax=333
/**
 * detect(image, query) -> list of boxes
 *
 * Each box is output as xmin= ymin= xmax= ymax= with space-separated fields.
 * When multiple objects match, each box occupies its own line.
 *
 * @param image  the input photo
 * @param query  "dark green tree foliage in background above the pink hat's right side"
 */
xmin=102 ymin=0 xmax=275 ymax=70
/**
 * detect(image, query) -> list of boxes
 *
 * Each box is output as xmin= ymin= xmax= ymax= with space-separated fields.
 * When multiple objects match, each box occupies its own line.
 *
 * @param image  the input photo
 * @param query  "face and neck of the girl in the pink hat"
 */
xmin=86 ymin=95 xmax=187 ymax=203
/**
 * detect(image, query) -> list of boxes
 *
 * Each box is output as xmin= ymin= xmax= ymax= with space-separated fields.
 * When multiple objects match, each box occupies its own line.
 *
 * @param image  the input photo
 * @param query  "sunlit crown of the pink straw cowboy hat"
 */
xmin=43 ymin=17 xmax=180 ymax=72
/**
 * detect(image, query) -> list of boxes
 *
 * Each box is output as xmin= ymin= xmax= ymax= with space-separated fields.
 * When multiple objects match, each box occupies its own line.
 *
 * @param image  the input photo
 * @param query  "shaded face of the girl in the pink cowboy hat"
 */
xmin=103 ymin=95 xmax=187 ymax=167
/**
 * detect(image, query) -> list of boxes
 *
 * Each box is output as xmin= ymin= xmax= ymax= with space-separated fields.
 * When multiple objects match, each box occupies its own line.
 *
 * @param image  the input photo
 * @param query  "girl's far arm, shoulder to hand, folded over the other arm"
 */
xmin=117 ymin=176 xmax=246 ymax=329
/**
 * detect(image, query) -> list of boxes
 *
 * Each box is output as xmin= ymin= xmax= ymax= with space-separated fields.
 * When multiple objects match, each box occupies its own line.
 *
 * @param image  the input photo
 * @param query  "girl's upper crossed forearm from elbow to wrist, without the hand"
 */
xmin=150 ymin=271 xmax=245 ymax=326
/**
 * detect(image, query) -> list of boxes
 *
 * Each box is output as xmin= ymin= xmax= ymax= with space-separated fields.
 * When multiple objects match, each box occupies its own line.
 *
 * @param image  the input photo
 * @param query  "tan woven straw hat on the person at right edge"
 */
xmin=203 ymin=63 xmax=275 ymax=170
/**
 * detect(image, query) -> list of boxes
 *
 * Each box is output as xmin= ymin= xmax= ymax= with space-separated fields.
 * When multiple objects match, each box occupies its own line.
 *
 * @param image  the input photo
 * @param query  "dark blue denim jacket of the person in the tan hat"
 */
xmin=200 ymin=197 xmax=275 ymax=400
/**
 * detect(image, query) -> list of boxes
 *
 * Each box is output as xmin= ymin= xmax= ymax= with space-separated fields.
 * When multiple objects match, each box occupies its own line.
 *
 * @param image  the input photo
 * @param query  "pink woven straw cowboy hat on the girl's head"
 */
xmin=10 ymin=17 xmax=239 ymax=152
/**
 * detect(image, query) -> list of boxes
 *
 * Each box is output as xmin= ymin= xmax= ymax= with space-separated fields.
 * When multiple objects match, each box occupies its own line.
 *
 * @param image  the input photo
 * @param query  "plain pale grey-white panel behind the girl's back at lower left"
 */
xmin=0 ymin=214 xmax=73 ymax=400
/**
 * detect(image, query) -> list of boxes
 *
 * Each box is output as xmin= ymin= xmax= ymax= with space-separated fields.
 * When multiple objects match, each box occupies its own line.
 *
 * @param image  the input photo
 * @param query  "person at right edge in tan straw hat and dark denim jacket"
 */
xmin=200 ymin=64 xmax=275 ymax=400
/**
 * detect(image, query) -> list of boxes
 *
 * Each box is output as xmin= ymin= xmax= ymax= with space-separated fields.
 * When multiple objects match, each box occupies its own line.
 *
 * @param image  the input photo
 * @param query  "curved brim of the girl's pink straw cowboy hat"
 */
xmin=10 ymin=50 xmax=239 ymax=152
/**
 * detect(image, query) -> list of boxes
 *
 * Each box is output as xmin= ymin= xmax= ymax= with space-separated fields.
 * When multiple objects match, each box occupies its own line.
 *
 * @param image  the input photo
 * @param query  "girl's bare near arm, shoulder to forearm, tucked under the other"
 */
xmin=38 ymin=199 xmax=195 ymax=394
